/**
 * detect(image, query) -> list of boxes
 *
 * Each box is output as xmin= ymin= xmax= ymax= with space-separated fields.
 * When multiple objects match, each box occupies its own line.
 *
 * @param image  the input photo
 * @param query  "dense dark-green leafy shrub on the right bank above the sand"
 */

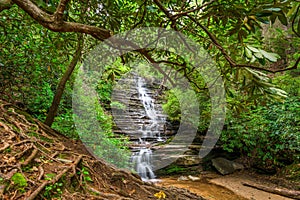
xmin=221 ymin=97 xmax=300 ymax=168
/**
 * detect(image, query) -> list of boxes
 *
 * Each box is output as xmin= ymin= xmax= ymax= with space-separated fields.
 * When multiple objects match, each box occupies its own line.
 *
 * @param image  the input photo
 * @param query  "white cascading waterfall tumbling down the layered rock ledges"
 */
xmin=132 ymin=77 xmax=166 ymax=180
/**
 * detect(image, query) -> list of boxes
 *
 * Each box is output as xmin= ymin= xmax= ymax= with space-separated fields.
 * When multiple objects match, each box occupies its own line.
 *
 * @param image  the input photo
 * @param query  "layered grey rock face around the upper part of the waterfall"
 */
xmin=112 ymin=73 xmax=176 ymax=142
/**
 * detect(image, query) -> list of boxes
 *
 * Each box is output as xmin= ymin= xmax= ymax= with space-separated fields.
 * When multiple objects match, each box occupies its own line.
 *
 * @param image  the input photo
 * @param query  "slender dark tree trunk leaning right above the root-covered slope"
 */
xmin=44 ymin=34 xmax=83 ymax=127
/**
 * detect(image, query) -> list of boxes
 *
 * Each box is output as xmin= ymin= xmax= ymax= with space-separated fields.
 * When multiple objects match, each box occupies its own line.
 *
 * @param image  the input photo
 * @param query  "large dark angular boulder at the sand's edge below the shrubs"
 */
xmin=212 ymin=158 xmax=244 ymax=175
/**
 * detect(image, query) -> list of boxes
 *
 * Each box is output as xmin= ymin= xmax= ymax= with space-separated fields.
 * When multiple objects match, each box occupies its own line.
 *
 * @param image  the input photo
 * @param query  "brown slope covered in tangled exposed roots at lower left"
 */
xmin=0 ymin=100 xmax=203 ymax=200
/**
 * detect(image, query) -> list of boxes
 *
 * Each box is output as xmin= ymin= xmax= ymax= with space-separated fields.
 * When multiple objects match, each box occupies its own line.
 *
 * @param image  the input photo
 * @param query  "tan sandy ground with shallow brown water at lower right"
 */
xmin=157 ymin=173 xmax=291 ymax=200
